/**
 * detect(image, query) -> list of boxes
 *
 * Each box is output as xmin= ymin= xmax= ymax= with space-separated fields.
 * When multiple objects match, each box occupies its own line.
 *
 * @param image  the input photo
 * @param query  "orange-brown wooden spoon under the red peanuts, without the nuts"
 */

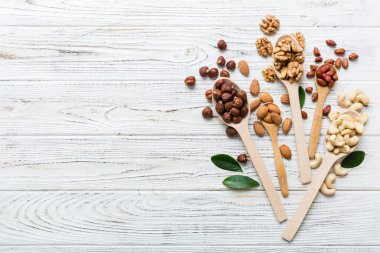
xmin=308 ymin=64 xmax=334 ymax=158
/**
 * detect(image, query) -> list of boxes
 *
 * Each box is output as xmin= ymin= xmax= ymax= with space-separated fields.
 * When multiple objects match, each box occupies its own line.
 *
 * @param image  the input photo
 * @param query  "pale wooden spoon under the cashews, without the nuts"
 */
xmin=282 ymin=110 xmax=361 ymax=241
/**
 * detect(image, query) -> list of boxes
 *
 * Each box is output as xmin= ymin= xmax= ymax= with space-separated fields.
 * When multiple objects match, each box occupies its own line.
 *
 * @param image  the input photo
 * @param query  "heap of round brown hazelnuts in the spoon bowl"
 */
xmin=213 ymin=79 xmax=249 ymax=124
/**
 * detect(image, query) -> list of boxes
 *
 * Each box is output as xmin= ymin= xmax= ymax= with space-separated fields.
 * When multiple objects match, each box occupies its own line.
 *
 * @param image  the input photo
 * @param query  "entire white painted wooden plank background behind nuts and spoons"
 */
xmin=0 ymin=0 xmax=380 ymax=253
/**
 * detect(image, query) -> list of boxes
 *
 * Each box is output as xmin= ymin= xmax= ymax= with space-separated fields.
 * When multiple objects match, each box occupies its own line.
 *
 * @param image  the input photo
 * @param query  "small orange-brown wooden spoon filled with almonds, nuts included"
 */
xmin=256 ymin=103 xmax=289 ymax=197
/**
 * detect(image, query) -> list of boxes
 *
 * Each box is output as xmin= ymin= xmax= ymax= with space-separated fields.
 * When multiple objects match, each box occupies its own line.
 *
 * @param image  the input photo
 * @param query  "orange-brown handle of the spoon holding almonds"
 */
xmin=271 ymin=131 xmax=289 ymax=198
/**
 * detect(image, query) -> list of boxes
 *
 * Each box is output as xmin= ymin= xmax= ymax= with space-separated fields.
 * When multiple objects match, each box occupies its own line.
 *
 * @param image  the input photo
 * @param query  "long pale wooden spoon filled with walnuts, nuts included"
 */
xmin=273 ymin=35 xmax=311 ymax=184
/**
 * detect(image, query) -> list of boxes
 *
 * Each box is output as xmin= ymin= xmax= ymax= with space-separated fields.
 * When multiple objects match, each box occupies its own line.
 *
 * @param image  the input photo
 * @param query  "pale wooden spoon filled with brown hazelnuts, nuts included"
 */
xmin=212 ymin=77 xmax=287 ymax=222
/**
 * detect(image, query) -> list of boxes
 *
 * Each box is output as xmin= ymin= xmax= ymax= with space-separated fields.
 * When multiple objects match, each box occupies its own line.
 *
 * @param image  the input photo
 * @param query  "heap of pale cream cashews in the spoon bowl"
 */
xmin=326 ymin=114 xmax=364 ymax=154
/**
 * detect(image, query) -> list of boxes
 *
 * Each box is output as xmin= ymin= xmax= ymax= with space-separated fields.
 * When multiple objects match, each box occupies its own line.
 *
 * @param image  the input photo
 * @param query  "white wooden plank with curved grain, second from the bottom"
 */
xmin=0 ymin=191 xmax=380 ymax=246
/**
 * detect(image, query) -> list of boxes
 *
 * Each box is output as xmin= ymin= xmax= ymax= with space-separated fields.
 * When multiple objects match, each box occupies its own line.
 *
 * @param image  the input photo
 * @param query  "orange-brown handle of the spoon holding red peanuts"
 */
xmin=308 ymin=92 xmax=326 ymax=158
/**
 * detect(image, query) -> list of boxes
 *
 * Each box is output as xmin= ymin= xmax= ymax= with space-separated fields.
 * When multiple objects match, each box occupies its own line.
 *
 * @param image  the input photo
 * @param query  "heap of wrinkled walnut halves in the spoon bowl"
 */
xmin=273 ymin=36 xmax=305 ymax=83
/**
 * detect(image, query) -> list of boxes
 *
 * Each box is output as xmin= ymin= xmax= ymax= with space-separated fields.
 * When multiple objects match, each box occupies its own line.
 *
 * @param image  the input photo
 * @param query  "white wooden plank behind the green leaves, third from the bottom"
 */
xmin=0 ymin=136 xmax=380 ymax=192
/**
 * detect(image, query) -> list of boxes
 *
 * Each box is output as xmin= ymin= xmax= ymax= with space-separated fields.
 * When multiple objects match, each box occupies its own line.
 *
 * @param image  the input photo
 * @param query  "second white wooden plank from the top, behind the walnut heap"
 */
xmin=0 ymin=26 xmax=380 ymax=81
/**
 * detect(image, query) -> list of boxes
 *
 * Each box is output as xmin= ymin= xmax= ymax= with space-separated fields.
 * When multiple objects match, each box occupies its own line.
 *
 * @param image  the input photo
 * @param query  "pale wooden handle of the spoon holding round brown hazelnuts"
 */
xmin=236 ymin=127 xmax=288 ymax=222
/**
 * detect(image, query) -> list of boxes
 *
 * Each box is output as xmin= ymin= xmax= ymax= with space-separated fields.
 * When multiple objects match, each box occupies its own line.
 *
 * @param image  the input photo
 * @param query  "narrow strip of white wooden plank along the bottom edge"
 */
xmin=0 ymin=245 xmax=380 ymax=253
